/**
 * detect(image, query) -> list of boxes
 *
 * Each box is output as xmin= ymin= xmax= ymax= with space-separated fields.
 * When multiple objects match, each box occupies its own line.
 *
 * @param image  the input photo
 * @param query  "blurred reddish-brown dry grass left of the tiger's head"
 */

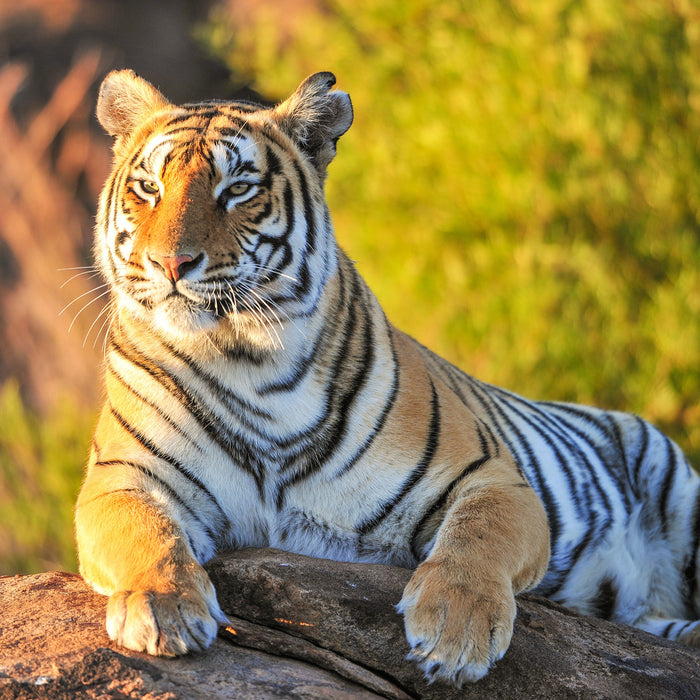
xmin=0 ymin=53 xmax=108 ymax=409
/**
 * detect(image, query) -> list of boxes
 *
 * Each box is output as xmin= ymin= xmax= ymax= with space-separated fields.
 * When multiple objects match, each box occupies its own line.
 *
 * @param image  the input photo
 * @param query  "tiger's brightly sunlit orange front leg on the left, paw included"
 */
xmin=76 ymin=466 xmax=226 ymax=656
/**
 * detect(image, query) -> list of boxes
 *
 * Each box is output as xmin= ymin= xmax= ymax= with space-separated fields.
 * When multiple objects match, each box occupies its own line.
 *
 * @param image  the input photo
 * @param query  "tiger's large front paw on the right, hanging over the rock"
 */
xmin=397 ymin=560 xmax=516 ymax=688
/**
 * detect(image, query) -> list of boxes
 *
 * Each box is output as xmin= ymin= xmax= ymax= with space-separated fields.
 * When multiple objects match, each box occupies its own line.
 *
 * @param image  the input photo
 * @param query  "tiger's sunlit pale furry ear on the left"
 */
xmin=97 ymin=70 xmax=169 ymax=138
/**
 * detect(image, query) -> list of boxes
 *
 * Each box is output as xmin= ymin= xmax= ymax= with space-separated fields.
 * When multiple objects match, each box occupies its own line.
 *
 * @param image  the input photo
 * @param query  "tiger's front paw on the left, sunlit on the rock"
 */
xmin=107 ymin=584 xmax=226 ymax=656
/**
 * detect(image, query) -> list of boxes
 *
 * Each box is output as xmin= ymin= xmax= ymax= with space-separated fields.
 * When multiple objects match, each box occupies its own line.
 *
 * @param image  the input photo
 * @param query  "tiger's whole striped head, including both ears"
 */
xmin=95 ymin=70 xmax=353 ymax=348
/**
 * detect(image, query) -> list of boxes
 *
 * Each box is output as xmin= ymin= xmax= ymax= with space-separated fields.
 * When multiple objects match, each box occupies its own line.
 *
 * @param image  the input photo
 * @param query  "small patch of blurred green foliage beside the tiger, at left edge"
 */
xmin=0 ymin=383 xmax=95 ymax=575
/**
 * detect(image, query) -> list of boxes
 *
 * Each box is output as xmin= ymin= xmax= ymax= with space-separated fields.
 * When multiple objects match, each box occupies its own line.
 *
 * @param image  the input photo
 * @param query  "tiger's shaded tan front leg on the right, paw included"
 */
xmin=397 ymin=472 xmax=549 ymax=687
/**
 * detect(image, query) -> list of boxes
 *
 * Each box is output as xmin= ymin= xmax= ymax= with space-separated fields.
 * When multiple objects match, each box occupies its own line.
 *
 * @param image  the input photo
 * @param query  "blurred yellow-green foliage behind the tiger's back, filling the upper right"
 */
xmin=202 ymin=0 xmax=700 ymax=465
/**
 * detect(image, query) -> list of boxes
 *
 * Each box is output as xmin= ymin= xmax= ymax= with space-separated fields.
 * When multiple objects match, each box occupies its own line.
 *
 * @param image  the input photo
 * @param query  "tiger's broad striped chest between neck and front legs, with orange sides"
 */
xmin=108 ymin=326 xmax=474 ymax=566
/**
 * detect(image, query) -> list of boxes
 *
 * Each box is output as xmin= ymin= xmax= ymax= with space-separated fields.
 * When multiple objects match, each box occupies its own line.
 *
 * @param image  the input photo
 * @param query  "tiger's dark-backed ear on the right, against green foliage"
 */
xmin=273 ymin=72 xmax=353 ymax=179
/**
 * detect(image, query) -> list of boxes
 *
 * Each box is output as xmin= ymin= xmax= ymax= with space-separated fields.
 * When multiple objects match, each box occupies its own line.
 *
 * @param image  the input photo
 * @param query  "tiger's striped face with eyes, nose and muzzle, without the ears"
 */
xmin=102 ymin=120 xmax=300 ymax=344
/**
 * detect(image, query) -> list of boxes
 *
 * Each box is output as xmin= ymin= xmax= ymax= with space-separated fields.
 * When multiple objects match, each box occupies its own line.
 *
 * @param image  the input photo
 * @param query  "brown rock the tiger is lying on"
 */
xmin=0 ymin=549 xmax=700 ymax=700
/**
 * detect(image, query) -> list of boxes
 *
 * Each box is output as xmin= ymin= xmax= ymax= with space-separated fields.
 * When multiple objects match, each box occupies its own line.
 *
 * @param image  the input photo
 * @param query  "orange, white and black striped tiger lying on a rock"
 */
xmin=75 ymin=70 xmax=700 ymax=687
